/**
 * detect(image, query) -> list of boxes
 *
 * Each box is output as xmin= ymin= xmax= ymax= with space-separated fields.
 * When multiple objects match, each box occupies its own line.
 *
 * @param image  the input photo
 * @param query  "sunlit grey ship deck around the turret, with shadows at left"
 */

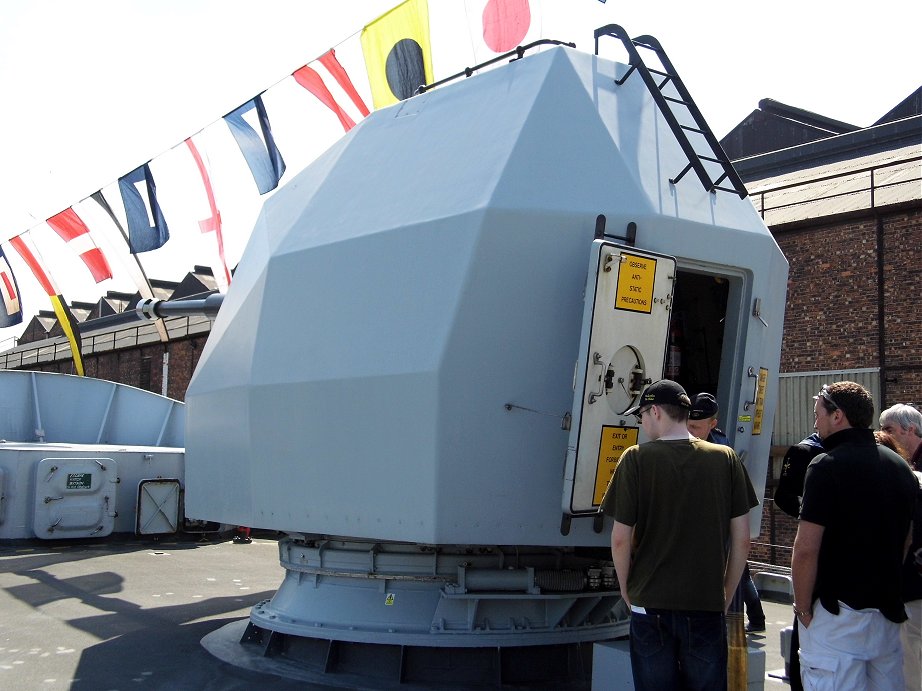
xmin=0 ymin=535 xmax=792 ymax=691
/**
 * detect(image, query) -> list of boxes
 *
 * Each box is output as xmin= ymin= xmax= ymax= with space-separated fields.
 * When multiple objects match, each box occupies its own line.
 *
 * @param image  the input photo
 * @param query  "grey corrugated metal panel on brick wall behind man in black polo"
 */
xmin=772 ymin=367 xmax=880 ymax=446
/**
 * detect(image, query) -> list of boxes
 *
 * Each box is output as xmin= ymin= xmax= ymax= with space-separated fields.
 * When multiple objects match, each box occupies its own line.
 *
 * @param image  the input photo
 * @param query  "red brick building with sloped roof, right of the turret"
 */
xmin=722 ymin=89 xmax=922 ymax=566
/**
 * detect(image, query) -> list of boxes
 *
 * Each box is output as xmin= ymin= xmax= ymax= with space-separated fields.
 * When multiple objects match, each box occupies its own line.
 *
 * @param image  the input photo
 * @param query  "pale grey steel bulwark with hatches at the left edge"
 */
xmin=0 ymin=370 xmax=185 ymax=540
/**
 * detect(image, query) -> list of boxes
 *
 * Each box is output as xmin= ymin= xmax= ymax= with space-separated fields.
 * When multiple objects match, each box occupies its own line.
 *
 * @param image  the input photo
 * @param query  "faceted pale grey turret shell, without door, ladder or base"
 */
xmin=186 ymin=48 xmax=787 ymax=547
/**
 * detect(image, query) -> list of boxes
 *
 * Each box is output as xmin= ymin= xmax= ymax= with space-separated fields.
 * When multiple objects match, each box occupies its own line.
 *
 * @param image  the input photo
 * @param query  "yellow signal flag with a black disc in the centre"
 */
xmin=362 ymin=0 xmax=433 ymax=108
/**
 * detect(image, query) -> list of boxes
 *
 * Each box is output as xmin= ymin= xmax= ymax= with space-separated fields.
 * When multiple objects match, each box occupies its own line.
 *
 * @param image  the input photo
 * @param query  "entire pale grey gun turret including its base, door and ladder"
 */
xmin=186 ymin=26 xmax=787 ymax=687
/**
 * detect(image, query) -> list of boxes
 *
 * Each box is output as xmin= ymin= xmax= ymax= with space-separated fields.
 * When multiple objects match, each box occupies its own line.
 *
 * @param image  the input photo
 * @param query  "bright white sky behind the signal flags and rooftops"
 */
xmin=0 ymin=0 xmax=922 ymax=350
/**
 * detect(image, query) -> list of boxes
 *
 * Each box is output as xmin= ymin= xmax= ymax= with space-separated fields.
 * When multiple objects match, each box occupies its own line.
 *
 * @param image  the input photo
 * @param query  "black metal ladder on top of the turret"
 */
xmin=595 ymin=24 xmax=749 ymax=199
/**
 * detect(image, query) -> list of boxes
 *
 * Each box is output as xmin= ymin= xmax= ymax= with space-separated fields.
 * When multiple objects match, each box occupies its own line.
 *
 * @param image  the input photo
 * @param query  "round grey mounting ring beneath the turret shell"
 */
xmin=250 ymin=538 xmax=629 ymax=648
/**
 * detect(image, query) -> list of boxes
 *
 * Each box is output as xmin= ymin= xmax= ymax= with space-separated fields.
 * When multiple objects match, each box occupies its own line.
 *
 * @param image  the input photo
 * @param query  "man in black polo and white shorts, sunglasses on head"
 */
xmin=791 ymin=381 xmax=918 ymax=691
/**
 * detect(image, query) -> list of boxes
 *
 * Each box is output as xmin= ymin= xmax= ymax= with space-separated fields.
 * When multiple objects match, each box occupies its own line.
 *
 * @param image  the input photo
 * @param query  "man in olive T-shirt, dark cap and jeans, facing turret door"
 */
xmin=601 ymin=379 xmax=758 ymax=691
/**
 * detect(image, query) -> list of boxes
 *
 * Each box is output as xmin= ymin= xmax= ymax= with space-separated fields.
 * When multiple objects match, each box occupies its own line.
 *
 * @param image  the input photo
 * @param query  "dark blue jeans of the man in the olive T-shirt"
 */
xmin=631 ymin=609 xmax=727 ymax=691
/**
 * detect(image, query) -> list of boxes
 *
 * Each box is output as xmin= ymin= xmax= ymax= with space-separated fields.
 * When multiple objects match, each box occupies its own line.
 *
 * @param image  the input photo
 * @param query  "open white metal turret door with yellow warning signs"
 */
xmin=561 ymin=240 xmax=676 ymax=533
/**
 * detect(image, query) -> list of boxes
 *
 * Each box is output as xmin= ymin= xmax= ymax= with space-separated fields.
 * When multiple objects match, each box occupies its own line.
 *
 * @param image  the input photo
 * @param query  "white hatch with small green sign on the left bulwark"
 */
xmin=32 ymin=458 xmax=118 ymax=540
